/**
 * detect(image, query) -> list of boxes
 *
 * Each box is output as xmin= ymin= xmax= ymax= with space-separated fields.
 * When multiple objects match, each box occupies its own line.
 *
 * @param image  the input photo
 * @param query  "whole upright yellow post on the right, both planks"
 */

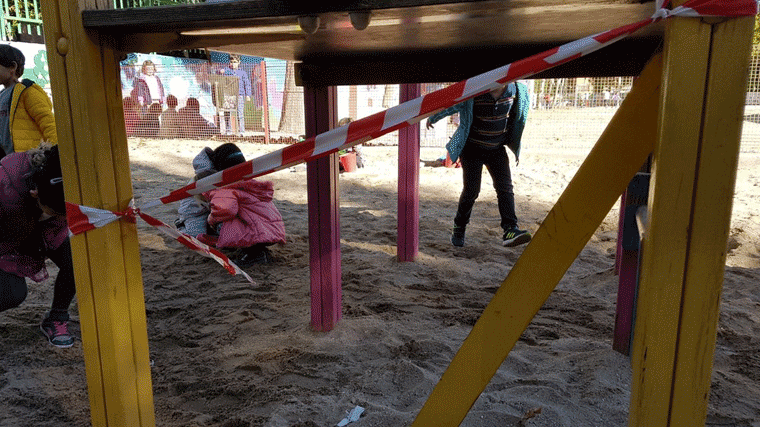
xmin=629 ymin=7 xmax=754 ymax=427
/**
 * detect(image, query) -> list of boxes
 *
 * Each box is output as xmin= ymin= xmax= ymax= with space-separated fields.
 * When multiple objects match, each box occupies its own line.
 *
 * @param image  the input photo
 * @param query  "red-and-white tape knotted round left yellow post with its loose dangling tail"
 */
xmin=66 ymin=202 xmax=255 ymax=284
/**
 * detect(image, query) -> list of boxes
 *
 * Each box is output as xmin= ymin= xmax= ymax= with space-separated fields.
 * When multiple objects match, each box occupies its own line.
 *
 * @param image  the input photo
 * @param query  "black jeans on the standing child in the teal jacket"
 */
xmin=454 ymin=143 xmax=517 ymax=230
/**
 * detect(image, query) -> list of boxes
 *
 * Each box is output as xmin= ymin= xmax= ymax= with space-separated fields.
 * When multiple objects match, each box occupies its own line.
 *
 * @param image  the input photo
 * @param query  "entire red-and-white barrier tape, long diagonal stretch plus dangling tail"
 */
xmin=67 ymin=0 xmax=758 ymax=281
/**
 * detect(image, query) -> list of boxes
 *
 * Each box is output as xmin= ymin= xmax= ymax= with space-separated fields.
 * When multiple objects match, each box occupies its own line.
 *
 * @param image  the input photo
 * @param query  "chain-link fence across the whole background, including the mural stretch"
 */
xmin=122 ymin=52 xmax=760 ymax=153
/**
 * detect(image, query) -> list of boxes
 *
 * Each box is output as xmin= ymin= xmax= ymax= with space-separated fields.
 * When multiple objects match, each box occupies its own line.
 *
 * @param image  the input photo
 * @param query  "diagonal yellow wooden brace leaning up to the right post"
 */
xmin=413 ymin=51 xmax=662 ymax=427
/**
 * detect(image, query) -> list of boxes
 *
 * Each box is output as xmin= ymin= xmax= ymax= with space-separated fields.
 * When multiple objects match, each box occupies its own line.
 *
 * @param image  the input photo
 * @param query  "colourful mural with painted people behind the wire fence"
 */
xmin=121 ymin=52 xmax=292 ymax=142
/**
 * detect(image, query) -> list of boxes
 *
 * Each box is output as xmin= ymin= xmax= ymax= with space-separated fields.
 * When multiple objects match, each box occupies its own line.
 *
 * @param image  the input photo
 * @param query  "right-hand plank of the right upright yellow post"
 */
xmin=669 ymin=17 xmax=754 ymax=426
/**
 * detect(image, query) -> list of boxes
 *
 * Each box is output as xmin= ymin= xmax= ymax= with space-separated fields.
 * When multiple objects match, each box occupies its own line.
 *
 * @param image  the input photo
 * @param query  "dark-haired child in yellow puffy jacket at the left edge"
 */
xmin=0 ymin=44 xmax=58 ymax=158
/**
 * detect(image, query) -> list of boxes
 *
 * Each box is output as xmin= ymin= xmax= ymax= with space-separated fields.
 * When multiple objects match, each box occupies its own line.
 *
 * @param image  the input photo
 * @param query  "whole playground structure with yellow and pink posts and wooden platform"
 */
xmin=38 ymin=1 xmax=753 ymax=426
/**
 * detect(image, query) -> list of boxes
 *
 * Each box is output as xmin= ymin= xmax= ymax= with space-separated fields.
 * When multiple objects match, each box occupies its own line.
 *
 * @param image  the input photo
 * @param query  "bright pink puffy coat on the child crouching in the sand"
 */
xmin=204 ymin=179 xmax=285 ymax=248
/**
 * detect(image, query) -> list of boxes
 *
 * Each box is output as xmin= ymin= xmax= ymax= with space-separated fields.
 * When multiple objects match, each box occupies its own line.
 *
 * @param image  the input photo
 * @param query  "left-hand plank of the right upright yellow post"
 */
xmin=629 ymin=11 xmax=710 ymax=427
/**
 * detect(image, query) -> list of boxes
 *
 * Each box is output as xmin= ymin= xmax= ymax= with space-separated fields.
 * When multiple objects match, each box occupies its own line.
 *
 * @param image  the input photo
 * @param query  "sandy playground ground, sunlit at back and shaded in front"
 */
xmin=0 ymin=133 xmax=760 ymax=427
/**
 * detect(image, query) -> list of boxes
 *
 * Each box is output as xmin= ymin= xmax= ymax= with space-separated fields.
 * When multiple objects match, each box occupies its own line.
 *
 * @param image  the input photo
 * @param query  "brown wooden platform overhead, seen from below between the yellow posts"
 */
xmin=82 ymin=0 xmax=664 ymax=86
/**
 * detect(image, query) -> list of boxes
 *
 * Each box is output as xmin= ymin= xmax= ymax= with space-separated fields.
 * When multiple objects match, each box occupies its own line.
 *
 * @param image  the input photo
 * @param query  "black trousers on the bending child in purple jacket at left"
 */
xmin=0 ymin=239 xmax=76 ymax=321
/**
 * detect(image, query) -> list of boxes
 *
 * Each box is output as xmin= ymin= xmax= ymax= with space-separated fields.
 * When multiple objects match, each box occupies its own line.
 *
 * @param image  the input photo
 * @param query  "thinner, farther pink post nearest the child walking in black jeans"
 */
xmin=396 ymin=83 xmax=421 ymax=262
